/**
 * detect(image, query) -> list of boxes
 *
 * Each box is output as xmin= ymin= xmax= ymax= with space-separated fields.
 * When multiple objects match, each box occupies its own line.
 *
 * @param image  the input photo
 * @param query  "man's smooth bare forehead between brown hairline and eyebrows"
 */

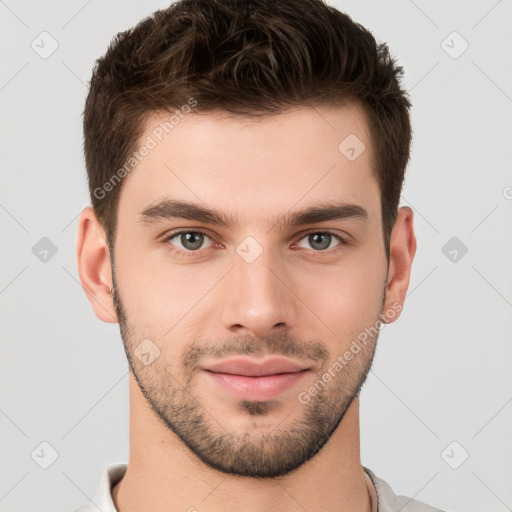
xmin=118 ymin=104 xmax=380 ymax=222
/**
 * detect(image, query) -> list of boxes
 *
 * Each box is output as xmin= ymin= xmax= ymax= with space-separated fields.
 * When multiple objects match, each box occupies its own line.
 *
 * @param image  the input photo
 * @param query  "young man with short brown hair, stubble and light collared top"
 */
xmin=77 ymin=0 xmax=444 ymax=512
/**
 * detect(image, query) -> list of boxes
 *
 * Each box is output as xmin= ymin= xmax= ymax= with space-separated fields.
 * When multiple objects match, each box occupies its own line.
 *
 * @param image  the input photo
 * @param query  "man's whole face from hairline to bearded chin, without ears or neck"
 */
xmin=111 ymin=105 xmax=388 ymax=477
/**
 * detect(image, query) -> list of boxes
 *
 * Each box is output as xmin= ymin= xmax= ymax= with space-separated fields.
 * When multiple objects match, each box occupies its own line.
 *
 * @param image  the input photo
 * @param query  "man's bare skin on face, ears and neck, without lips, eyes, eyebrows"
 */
xmin=77 ymin=104 xmax=416 ymax=512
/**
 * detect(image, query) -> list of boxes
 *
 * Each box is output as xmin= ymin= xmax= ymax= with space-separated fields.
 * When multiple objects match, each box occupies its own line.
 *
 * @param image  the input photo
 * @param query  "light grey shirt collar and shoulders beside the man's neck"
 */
xmin=74 ymin=464 xmax=443 ymax=512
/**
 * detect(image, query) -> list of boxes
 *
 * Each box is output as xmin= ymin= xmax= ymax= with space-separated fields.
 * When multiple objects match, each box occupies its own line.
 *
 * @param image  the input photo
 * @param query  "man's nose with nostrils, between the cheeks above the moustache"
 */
xmin=222 ymin=244 xmax=298 ymax=337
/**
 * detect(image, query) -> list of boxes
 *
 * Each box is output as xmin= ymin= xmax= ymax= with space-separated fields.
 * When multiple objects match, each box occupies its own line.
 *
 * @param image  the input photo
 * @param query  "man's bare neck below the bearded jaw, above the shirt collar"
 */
xmin=112 ymin=374 xmax=370 ymax=512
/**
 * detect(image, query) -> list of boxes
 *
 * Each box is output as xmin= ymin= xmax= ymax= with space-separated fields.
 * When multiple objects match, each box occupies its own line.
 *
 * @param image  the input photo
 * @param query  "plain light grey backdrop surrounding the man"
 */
xmin=0 ymin=0 xmax=512 ymax=512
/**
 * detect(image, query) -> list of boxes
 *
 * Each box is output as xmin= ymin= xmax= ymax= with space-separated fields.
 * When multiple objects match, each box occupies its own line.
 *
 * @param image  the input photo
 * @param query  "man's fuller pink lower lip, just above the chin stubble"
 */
xmin=206 ymin=370 xmax=308 ymax=401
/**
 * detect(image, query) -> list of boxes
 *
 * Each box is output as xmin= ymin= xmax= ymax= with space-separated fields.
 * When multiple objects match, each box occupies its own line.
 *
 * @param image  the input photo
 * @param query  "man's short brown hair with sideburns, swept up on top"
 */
xmin=84 ymin=0 xmax=412 ymax=259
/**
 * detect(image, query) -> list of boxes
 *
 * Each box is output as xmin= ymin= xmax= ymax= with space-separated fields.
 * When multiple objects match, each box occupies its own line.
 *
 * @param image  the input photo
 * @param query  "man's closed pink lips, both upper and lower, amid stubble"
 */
xmin=204 ymin=358 xmax=310 ymax=401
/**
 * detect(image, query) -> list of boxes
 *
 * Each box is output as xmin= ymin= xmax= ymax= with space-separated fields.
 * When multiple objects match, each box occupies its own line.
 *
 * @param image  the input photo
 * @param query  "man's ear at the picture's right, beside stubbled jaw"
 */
xmin=381 ymin=206 xmax=416 ymax=324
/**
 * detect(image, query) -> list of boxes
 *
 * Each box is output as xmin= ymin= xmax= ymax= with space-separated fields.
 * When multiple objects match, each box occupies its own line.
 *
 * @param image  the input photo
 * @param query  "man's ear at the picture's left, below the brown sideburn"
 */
xmin=76 ymin=206 xmax=118 ymax=323
